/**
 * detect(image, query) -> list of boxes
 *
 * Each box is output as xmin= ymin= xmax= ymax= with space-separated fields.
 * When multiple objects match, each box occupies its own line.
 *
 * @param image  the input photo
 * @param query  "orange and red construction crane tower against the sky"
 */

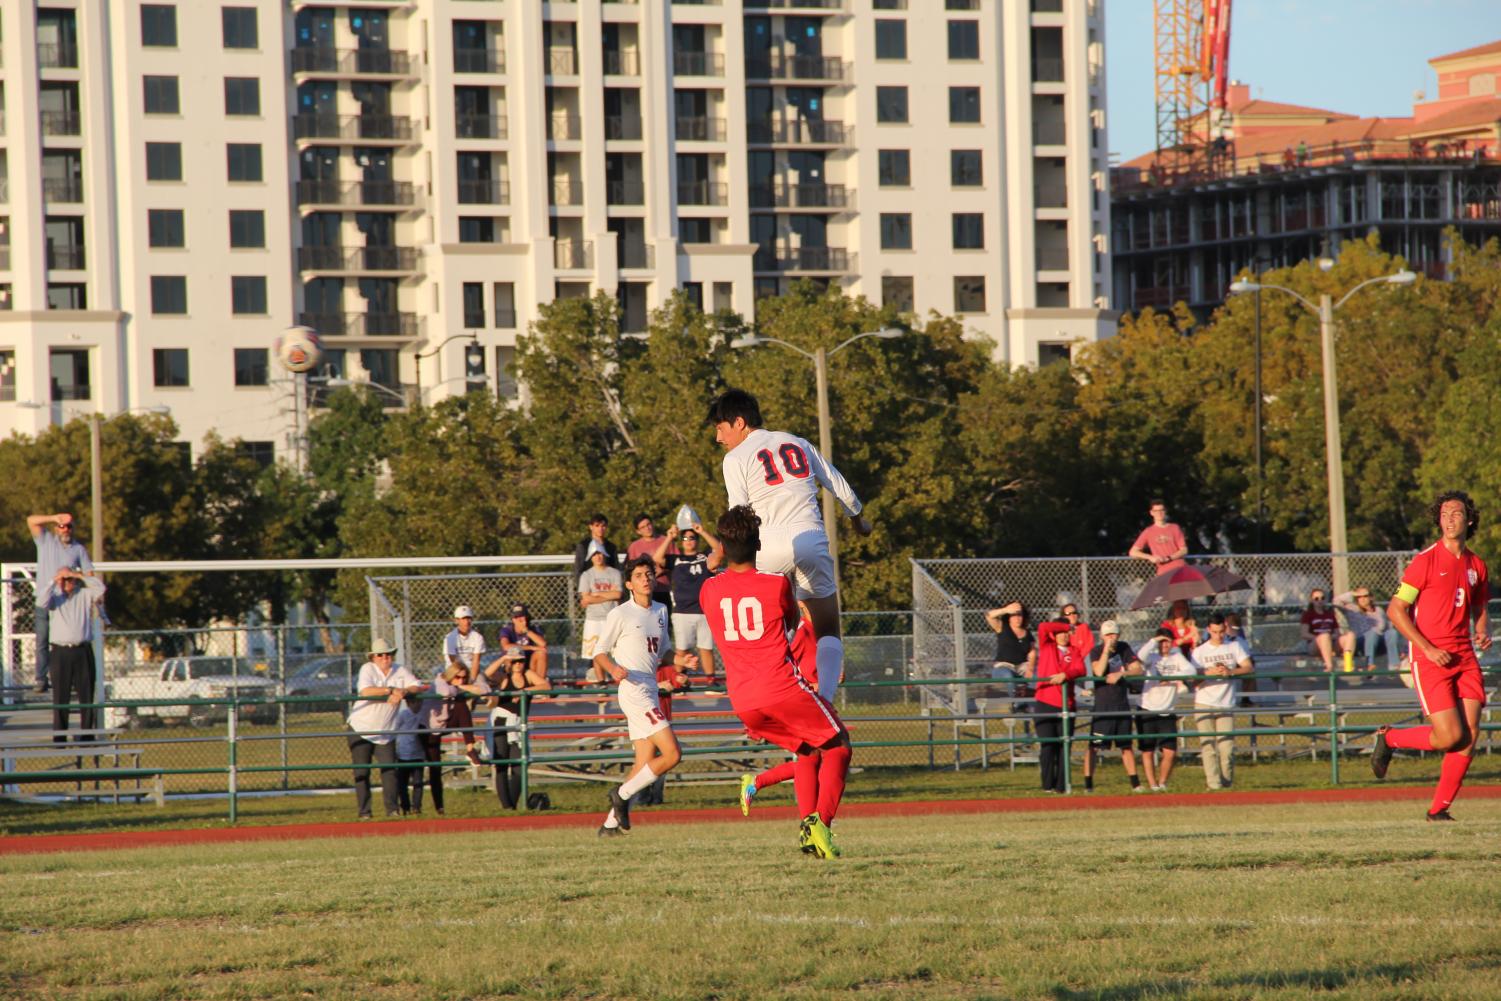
xmin=1153 ymin=0 xmax=1232 ymax=174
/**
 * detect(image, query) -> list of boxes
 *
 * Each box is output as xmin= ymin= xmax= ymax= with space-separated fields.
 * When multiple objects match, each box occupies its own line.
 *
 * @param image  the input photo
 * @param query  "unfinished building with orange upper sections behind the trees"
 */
xmin=1111 ymin=41 xmax=1501 ymax=311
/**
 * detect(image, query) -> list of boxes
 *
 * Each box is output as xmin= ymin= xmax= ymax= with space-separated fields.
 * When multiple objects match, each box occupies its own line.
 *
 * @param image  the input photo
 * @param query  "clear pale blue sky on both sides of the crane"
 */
xmin=1105 ymin=0 xmax=1501 ymax=162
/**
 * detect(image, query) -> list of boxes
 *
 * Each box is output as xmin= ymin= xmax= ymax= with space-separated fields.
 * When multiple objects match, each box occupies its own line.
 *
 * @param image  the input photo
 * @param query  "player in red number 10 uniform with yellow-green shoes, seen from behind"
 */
xmin=698 ymin=504 xmax=850 ymax=858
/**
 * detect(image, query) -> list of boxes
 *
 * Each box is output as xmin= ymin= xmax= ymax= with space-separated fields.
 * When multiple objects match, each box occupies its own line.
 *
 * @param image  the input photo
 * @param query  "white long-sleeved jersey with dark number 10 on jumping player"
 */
xmin=723 ymin=428 xmax=862 ymax=528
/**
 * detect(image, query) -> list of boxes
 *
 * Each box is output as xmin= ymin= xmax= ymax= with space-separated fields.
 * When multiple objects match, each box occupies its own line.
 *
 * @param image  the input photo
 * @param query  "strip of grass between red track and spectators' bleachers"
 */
xmin=0 ymin=752 xmax=1501 ymax=836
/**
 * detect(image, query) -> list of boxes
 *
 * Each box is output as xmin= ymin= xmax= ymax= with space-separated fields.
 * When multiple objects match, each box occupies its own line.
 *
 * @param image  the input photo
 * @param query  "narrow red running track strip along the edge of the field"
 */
xmin=0 ymin=786 xmax=1501 ymax=855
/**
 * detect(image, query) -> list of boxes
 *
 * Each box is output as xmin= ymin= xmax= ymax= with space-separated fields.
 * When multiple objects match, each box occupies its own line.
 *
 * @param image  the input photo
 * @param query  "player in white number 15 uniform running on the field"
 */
xmin=594 ymin=557 xmax=698 ymax=837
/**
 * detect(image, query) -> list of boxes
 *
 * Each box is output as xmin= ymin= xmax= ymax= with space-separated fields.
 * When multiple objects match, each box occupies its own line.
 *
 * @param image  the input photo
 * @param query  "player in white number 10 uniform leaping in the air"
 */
xmin=708 ymin=389 xmax=871 ymax=702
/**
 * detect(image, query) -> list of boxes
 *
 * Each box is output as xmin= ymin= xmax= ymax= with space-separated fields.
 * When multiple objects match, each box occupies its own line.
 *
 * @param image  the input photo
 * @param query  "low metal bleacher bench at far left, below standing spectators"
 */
xmin=0 ymin=729 xmax=167 ymax=806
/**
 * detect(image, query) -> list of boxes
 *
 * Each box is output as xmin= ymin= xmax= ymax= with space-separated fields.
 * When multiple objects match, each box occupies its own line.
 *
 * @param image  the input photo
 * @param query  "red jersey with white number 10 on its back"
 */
xmin=698 ymin=570 xmax=806 ymax=711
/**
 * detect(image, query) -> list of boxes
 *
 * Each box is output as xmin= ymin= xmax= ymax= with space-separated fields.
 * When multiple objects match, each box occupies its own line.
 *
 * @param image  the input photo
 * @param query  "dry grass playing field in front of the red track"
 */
xmin=0 ymin=800 xmax=1501 ymax=1001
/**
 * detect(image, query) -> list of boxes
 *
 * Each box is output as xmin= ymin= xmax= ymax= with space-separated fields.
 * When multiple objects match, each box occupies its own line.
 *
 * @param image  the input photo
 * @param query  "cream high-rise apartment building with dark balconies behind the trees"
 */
xmin=0 ymin=0 xmax=1114 ymax=458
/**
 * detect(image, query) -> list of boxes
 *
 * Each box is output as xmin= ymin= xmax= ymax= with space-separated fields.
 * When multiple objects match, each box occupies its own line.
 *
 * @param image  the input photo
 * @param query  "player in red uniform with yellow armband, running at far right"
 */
xmin=1370 ymin=491 xmax=1490 ymax=821
